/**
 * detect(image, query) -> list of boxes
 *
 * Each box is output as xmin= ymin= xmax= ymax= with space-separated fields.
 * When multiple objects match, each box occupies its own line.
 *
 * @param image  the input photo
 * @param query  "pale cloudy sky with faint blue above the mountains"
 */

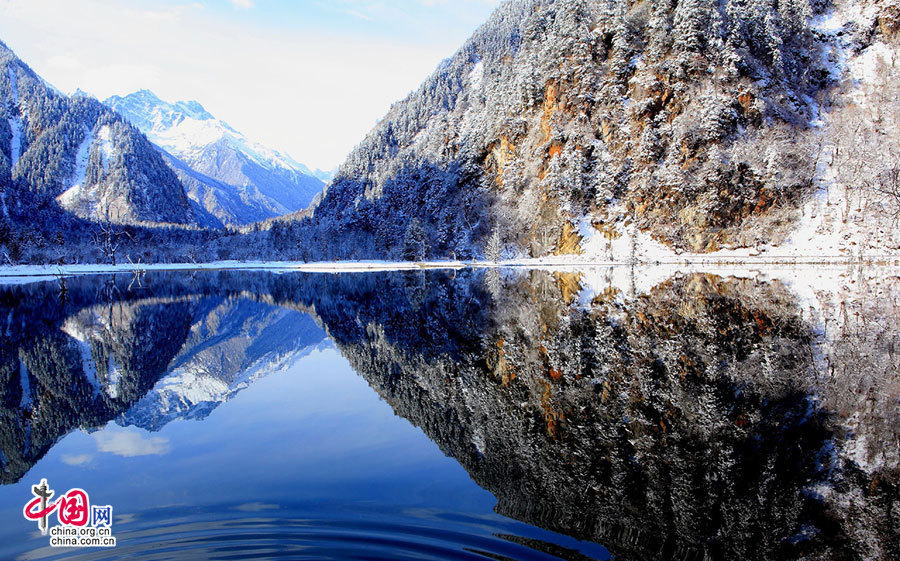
xmin=0 ymin=0 xmax=499 ymax=169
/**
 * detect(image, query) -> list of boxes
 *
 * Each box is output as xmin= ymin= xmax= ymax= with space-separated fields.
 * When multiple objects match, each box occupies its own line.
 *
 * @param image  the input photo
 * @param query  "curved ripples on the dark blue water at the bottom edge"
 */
xmin=18 ymin=503 xmax=609 ymax=561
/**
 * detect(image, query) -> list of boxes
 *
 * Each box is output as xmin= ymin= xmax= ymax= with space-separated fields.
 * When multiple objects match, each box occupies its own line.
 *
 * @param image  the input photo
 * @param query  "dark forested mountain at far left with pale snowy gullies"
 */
xmin=0 ymin=44 xmax=196 ymax=224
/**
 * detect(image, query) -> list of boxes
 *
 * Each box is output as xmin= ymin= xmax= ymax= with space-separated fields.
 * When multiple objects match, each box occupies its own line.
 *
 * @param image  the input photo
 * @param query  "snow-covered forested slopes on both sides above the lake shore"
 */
xmin=0 ymin=0 xmax=900 ymax=264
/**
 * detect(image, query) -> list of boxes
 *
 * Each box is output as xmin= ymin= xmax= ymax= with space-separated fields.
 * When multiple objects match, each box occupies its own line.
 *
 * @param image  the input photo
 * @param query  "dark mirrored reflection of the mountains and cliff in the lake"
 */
xmin=0 ymin=270 xmax=900 ymax=560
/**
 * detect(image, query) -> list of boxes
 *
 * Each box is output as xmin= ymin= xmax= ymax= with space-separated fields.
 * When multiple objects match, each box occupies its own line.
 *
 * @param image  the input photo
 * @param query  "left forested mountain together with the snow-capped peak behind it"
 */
xmin=0 ymin=38 xmax=329 ymax=245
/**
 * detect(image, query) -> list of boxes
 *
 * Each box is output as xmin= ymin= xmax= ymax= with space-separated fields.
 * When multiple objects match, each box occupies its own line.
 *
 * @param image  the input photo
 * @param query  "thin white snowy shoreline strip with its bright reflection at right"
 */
xmin=0 ymin=255 xmax=900 ymax=326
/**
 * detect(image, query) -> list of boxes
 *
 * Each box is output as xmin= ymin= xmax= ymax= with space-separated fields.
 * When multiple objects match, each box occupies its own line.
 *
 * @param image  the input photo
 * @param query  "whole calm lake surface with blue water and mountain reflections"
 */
xmin=0 ymin=269 xmax=900 ymax=561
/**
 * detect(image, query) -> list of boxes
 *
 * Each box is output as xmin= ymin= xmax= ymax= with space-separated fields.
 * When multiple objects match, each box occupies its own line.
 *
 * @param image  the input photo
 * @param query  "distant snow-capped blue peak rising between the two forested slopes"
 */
xmin=104 ymin=90 xmax=330 ymax=225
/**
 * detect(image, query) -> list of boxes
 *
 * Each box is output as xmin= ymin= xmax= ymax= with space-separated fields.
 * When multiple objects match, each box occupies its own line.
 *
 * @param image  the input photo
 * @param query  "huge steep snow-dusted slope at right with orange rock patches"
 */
xmin=286 ymin=0 xmax=900 ymax=258
